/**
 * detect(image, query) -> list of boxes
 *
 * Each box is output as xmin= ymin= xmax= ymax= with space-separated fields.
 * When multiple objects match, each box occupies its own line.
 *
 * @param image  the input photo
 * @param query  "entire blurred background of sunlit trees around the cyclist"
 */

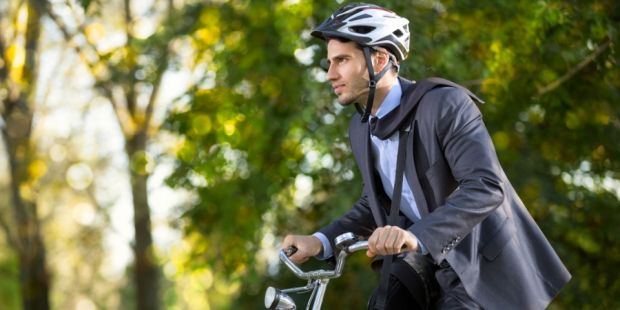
xmin=0 ymin=0 xmax=620 ymax=309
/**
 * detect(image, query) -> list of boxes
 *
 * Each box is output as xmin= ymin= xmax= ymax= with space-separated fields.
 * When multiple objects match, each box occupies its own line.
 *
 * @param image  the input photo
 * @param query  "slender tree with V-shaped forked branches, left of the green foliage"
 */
xmin=38 ymin=0 xmax=202 ymax=309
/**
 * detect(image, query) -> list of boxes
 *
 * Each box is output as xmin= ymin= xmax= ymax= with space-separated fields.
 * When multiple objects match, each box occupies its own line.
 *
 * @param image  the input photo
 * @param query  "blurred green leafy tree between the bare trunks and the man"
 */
xmin=166 ymin=1 xmax=370 ymax=309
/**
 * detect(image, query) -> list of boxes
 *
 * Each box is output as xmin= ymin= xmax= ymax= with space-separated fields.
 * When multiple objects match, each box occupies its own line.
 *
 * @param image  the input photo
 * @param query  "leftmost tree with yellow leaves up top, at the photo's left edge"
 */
xmin=0 ymin=1 xmax=50 ymax=309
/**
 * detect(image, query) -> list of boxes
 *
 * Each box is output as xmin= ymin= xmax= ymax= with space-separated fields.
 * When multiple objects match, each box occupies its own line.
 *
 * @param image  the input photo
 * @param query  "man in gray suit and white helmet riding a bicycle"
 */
xmin=282 ymin=3 xmax=571 ymax=309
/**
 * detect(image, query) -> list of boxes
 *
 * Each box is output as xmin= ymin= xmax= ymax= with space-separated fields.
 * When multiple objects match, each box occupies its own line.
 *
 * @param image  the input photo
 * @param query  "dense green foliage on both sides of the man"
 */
xmin=165 ymin=0 xmax=620 ymax=309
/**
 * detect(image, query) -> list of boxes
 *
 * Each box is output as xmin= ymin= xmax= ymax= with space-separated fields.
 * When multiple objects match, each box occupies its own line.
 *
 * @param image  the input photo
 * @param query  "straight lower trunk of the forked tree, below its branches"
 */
xmin=126 ymin=129 xmax=160 ymax=310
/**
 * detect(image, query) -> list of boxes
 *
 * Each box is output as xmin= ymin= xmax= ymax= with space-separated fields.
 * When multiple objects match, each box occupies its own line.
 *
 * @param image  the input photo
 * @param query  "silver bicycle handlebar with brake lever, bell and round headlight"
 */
xmin=265 ymin=233 xmax=368 ymax=310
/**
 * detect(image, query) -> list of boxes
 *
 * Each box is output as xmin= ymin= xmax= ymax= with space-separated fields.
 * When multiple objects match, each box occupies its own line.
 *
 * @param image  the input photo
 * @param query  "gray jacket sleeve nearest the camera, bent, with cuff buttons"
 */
xmin=410 ymin=88 xmax=504 ymax=263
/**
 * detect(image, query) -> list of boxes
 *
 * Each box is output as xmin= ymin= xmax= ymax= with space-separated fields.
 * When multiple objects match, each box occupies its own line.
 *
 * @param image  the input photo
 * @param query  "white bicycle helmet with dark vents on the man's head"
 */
xmin=311 ymin=3 xmax=409 ymax=61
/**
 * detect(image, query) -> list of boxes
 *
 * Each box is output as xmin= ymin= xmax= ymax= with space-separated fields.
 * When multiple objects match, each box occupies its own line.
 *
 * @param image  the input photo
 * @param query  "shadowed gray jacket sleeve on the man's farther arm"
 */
xmin=319 ymin=186 xmax=376 ymax=249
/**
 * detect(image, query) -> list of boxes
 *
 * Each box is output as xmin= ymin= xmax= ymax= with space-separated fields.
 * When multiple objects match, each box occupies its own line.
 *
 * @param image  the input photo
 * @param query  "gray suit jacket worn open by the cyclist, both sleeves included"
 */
xmin=320 ymin=79 xmax=571 ymax=309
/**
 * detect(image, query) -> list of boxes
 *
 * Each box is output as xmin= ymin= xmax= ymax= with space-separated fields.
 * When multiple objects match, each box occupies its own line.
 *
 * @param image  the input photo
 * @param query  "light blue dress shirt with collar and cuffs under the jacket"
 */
xmin=314 ymin=81 xmax=426 ymax=259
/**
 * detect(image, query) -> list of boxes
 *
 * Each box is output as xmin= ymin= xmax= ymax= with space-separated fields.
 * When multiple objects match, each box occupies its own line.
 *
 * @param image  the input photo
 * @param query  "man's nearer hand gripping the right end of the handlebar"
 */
xmin=366 ymin=225 xmax=418 ymax=257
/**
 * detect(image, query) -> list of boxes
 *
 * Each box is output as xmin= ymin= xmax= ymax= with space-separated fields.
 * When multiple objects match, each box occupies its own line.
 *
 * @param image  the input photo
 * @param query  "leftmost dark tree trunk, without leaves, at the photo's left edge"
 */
xmin=1 ymin=1 xmax=50 ymax=310
